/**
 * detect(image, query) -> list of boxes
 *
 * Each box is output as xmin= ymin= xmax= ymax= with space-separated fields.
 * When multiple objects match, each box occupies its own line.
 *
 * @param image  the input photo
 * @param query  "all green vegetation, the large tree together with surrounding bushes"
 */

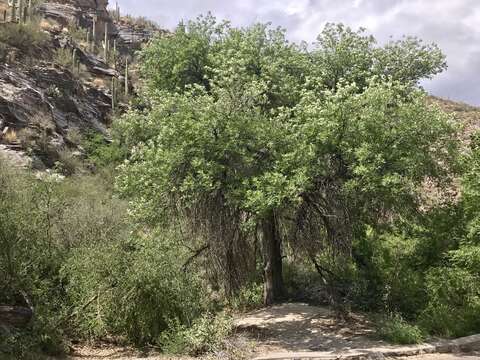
xmin=0 ymin=11 xmax=480 ymax=358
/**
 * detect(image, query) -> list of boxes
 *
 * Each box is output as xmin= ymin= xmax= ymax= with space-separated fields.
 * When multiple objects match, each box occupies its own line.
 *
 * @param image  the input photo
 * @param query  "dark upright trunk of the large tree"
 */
xmin=262 ymin=213 xmax=283 ymax=306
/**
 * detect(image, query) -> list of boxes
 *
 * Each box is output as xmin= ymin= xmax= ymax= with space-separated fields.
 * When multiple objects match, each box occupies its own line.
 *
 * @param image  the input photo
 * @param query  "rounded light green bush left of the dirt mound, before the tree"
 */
xmin=62 ymin=234 xmax=206 ymax=345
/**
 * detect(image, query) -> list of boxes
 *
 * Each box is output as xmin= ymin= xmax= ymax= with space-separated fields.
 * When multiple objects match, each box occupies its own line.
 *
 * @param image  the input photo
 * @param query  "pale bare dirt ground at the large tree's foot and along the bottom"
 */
xmin=62 ymin=304 xmax=480 ymax=360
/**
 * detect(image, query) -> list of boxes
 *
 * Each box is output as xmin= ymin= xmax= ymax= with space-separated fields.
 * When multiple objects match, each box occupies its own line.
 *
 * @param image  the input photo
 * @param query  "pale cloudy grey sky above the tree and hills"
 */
xmin=116 ymin=0 xmax=480 ymax=105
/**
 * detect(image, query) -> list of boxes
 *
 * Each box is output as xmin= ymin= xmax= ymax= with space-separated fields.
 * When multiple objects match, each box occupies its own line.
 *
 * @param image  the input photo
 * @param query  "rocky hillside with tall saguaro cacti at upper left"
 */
xmin=0 ymin=0 xmax=159 ymax=169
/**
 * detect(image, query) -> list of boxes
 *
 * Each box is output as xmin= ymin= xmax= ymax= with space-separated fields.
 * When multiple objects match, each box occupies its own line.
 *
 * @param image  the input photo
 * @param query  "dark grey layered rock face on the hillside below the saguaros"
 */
xmin=0 ymin=64 xmax=111 ymax=168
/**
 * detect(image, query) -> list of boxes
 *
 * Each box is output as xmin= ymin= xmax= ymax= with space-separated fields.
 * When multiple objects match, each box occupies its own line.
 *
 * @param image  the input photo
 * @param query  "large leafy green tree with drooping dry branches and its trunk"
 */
xmin=118 ymin=16 xmax=454 ymax=304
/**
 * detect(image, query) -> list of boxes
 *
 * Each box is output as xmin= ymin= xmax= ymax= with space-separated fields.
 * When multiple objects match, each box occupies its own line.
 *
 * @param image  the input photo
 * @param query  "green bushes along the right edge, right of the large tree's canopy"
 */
xmin=414 ymin=134 xmax=480 ymax=336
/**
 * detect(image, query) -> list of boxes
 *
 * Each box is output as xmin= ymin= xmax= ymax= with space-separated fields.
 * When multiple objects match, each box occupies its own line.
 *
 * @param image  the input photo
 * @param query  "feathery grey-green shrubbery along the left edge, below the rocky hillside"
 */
xmin=0 ymin=159 xmax=126 ymax=358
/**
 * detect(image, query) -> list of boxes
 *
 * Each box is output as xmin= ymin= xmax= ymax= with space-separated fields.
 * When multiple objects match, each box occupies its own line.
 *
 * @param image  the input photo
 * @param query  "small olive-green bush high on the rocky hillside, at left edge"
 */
xmin=0 ymin=23 xmax=48 ymax=55
